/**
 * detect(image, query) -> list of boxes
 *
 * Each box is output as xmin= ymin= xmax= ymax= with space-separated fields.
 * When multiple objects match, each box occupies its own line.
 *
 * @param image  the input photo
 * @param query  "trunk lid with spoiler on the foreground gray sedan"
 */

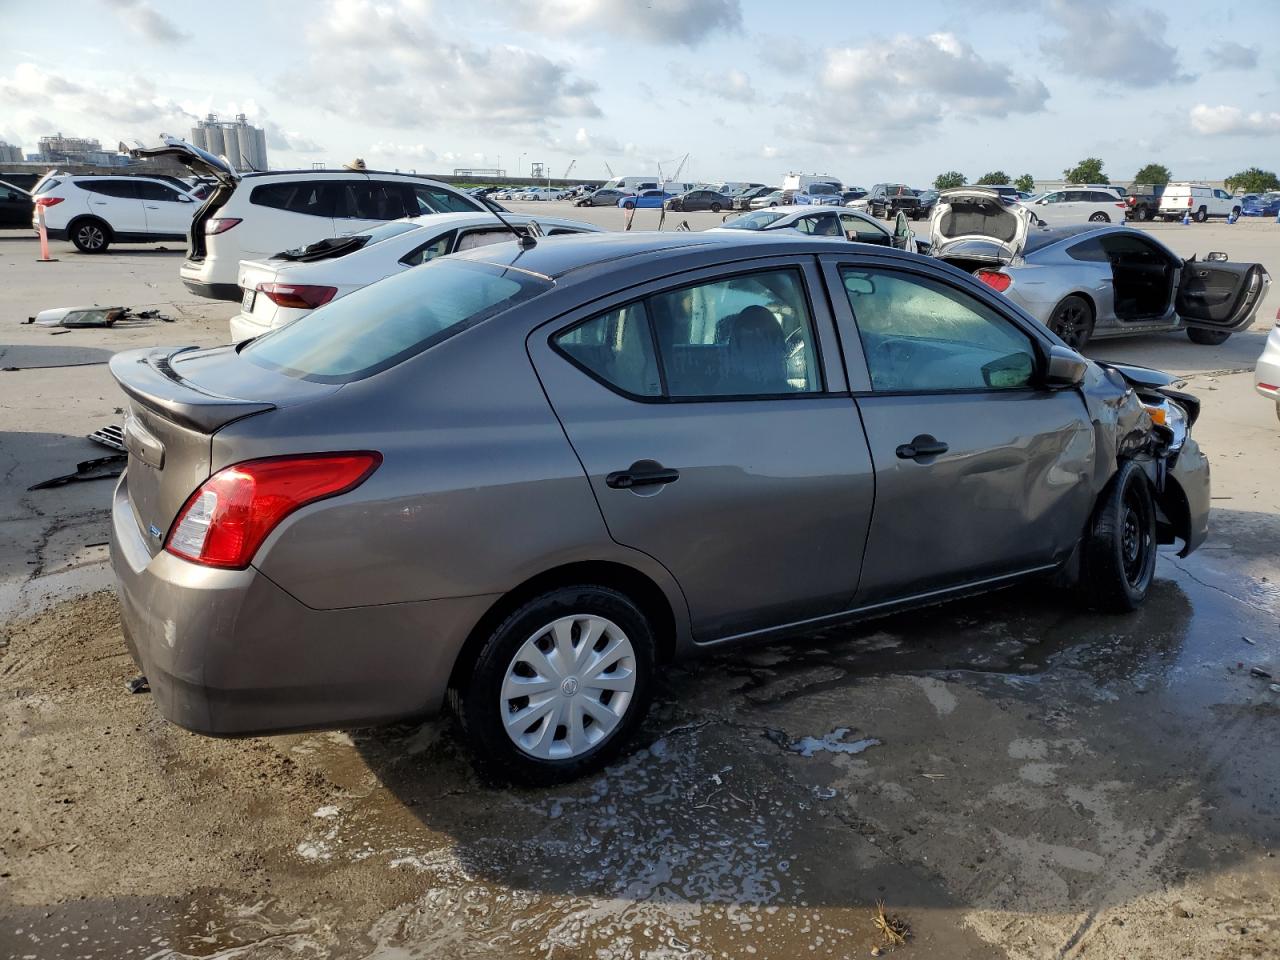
xmin=110 ymin=347 xmax=338 ymax=556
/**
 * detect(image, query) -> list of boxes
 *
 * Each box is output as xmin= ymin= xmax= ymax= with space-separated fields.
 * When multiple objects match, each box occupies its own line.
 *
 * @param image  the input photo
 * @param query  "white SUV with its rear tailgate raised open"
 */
xmin=129 ymin=137 xmax=488 ymax=301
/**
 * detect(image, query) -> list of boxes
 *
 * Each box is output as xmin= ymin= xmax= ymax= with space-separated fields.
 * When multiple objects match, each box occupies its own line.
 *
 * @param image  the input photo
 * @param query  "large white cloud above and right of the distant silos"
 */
xmin=283 ymin=0 xmax=600 ymax=134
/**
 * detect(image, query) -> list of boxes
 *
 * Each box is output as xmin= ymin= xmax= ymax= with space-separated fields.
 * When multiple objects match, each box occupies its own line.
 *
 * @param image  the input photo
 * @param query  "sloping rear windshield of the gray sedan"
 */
xmin=241 ymin=260 xmax=552 ymax=383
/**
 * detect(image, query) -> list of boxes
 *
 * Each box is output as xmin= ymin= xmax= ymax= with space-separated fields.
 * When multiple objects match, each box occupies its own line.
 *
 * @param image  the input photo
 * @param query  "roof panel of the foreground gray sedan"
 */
xmin=451 ymin=230 xmax=875 ymax=280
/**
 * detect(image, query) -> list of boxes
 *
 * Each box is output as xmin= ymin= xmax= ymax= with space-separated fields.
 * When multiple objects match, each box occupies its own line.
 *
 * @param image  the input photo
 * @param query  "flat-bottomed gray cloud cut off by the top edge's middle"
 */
xmin=521 ymin=0 xmax=742 ymax=46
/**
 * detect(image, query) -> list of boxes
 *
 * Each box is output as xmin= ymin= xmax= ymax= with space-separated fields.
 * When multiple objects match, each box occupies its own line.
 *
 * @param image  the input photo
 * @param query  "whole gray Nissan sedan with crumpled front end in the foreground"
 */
xmin=111 ymin=230 xmax=1210 ymax=783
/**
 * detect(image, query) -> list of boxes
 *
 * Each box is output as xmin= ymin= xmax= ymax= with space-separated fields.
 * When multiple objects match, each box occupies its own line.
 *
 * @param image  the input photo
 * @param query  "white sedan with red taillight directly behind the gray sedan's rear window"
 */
xmin=232 ymin=212 xmax=600 ymax=343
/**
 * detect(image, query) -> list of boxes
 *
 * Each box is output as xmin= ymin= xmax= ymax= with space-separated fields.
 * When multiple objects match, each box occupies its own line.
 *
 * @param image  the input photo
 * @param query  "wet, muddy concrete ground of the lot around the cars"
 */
xmin=0 ymin=217 xmax=1280 ymax=960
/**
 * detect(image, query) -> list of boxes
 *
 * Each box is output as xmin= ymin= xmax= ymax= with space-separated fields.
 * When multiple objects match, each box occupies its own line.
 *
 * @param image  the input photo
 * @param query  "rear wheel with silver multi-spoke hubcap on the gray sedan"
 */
xmin=457 ymin=585 xmax=654 ymax=786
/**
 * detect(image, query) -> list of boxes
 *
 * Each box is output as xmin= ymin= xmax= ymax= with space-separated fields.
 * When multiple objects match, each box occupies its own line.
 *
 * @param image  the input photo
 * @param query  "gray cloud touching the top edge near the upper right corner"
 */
xmin=1041 ymin=0 xmax=1193 ymax=87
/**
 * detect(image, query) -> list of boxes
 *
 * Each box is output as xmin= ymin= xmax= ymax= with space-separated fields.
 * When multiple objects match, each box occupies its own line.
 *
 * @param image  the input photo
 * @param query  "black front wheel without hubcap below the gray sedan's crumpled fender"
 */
xmin=1080 ymin=460 xmax=1156 ymax=613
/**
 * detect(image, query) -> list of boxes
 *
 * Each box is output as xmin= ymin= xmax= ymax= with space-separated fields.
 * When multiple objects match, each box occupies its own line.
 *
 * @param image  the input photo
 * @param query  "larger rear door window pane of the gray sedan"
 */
xmin=649 ymin=270 xmax=822 ymax=398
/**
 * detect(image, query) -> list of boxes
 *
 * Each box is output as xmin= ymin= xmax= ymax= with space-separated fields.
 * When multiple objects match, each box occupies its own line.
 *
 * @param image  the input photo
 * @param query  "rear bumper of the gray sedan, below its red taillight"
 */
xmin=111 ymin=471 xmax=494 ymax=736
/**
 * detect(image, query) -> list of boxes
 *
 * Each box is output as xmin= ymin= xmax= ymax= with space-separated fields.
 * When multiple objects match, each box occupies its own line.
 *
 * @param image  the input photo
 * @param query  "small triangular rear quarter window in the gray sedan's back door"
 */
xmin=556 ymin=303 xmax=662 ymax=397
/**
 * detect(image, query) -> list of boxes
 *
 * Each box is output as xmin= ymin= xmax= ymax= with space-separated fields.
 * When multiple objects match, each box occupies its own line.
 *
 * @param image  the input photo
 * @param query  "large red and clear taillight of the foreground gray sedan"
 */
xmin=164 ymin=452 xmax=383 ymax=570
